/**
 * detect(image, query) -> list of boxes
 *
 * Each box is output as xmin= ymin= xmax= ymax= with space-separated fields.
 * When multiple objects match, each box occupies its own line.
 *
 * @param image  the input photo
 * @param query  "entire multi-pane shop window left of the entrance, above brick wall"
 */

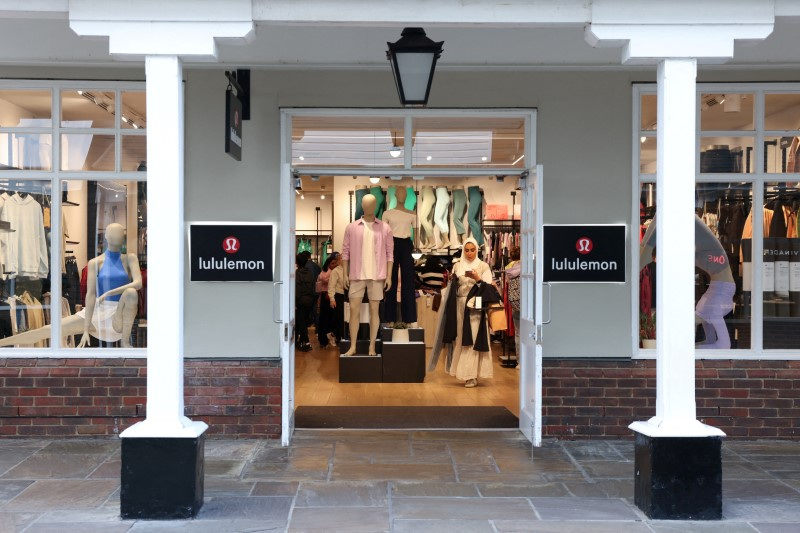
xmin=0 ymin=81 xmax=147 ymax=356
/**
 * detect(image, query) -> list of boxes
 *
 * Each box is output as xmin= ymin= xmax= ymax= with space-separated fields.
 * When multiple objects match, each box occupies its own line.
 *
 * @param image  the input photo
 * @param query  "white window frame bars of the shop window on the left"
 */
xmin=0 ymin=79 xmax=147 ymax=359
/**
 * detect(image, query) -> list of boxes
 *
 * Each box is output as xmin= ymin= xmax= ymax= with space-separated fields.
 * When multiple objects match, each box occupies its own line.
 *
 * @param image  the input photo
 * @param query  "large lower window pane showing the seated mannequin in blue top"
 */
xmin=61 ymin=180 xmax=147 ymax=348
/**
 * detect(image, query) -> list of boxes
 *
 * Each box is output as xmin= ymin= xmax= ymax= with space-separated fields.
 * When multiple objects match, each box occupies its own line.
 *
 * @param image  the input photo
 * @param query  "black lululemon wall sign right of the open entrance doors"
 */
xmin=542 ymin=225 xmax=626 ymax=283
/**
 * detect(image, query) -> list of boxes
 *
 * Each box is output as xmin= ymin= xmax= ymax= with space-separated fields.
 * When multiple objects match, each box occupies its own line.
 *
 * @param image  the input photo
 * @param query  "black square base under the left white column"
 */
xmin=120 ymin=434 xmax=205 ymax=520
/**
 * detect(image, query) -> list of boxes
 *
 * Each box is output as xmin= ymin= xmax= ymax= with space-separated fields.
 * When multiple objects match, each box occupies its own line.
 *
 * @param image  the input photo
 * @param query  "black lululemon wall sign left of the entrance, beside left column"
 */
xmin=189 ymin=224 xmax=272 ymax=281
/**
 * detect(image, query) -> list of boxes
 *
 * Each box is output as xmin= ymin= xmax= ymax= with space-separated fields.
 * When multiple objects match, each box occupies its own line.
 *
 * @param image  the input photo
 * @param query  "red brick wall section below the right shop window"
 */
xmin=542 ymin=359 xmax=800 ymax=438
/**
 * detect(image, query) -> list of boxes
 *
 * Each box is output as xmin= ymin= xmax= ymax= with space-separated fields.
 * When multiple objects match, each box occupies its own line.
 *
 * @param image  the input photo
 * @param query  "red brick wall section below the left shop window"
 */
xmin=0 ymin=358 xmax=281 ymax=438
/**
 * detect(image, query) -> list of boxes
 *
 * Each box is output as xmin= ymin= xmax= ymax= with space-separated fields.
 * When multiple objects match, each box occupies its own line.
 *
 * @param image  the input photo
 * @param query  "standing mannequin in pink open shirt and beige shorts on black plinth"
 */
xmin=342 ymin=194 xmax=394 ymax=355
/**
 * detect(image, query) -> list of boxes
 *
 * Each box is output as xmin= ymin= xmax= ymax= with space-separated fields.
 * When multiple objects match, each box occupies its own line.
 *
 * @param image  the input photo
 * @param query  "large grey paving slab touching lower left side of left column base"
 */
xmin=5 ymin=479 xmax=119 ymax=511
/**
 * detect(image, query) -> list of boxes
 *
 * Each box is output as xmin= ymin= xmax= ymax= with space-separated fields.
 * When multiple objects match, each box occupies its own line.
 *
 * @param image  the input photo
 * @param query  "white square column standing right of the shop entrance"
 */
xmin=631 ymin=58 xmax=723 ymax=437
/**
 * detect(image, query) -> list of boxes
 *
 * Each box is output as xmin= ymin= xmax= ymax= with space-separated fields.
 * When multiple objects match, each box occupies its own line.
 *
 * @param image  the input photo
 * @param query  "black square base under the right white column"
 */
xmin=634 ymin=432 xmax=722 ymax=520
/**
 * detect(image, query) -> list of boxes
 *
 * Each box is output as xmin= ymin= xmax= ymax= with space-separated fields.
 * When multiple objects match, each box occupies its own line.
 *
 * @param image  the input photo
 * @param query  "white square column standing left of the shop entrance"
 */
xmin=121 ymin=55 xmax=208 ymax=437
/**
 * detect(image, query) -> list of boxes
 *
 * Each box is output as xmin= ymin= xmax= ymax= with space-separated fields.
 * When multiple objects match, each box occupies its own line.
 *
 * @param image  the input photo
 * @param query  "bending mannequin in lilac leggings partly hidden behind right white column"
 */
xmin=639 ymin=216 xmax=736 ymax=349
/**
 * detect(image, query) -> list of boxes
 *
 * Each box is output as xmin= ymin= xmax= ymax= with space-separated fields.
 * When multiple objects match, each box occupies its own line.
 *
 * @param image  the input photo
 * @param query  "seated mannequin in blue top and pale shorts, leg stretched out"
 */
xmin=0 ymin=223 xmax=142 ymax=348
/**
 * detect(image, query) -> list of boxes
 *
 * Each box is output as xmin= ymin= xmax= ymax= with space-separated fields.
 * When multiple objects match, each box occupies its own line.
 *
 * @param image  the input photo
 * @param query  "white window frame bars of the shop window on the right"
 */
xmin=630 ymin=83 xmax=800 ymax=360
